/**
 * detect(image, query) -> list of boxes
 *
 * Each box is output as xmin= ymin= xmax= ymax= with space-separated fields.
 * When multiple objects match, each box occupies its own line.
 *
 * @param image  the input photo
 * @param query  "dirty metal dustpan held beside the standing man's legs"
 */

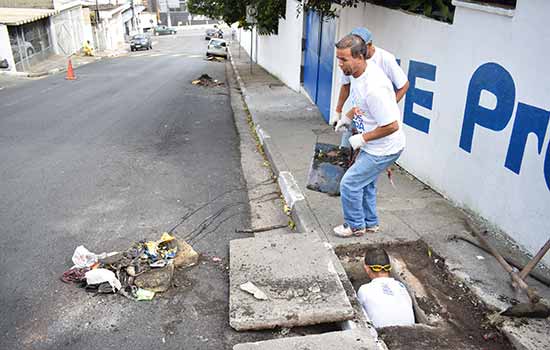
xmin=306 ymin=142 xmax=352 ymax=196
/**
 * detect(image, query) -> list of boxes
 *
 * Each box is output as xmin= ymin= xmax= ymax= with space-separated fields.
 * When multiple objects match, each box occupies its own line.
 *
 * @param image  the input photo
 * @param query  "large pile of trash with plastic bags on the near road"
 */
xmin=61 ymin=232 xmax=199 ymax=300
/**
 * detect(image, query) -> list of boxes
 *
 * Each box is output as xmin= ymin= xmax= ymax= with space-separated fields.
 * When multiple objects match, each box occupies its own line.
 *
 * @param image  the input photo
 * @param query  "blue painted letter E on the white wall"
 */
xmin=403 ymin=60 xmax=436 ymax=134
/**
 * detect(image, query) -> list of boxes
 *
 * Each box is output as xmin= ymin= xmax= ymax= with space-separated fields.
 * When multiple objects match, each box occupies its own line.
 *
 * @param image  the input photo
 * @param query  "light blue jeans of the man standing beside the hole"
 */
xmin=340 ymin=150 xmax=402 ymax=229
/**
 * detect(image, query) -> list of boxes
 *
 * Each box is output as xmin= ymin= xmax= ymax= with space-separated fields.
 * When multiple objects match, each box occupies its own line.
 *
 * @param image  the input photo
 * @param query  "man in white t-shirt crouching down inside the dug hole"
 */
xmin=357 ymin=248 xmax=414 ymax=328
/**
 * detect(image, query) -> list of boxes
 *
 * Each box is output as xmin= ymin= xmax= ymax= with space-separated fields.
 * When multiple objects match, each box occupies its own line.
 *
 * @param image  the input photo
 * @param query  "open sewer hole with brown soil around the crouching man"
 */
xmin=336 ymin=241 xmax=514 ymax=350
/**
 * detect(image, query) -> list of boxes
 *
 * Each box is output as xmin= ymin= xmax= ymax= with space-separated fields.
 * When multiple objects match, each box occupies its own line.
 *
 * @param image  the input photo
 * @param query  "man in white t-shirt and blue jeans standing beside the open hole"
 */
xmin=334 ymin=34 xmax=405 ymax=237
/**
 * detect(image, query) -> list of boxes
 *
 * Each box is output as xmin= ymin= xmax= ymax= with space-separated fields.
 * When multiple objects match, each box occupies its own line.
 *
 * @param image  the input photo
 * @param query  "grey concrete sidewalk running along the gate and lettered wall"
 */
xmin=226 ymin=44 xmax=550 ymax=349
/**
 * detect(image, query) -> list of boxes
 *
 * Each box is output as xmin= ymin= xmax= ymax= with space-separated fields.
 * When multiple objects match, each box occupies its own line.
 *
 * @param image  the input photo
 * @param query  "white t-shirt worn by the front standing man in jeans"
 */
xmin=350 ymin=63 xmax=405 ymax=156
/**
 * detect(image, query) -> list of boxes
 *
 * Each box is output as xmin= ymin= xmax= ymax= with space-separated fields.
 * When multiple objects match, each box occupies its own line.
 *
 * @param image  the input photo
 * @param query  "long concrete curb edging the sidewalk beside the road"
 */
xmin=229 ymin=50 xmax=324 ymax=239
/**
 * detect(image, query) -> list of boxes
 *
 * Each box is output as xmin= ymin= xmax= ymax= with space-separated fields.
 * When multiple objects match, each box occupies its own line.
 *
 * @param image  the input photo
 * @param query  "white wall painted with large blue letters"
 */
xmin=332 ymin=0 xmax=550 ymax=262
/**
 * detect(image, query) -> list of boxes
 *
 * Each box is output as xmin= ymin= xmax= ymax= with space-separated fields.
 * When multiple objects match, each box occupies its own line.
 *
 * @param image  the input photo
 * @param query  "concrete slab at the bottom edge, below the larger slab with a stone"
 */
xmin=233 ymin=329 xmax=380 ymax=350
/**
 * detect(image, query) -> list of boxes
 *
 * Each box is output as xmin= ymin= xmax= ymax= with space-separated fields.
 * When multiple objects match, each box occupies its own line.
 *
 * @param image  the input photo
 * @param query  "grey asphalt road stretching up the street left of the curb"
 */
xmin=0 ymin=34 xmax=269 ymax=350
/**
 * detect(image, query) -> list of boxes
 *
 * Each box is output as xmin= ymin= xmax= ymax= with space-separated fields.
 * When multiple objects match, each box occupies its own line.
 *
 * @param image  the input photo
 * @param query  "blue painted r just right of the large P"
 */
xmin=504 ymin=102 xmax=550 ymax=174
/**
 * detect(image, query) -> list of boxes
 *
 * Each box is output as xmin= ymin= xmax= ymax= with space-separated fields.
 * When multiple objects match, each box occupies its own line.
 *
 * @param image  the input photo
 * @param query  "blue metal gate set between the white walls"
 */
xmin=304 ymin=11 xmax=336 ymax=122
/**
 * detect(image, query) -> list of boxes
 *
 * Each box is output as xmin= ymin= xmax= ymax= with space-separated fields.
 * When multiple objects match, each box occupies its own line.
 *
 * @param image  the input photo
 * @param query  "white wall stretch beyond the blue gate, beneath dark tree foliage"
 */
xmin=234 ymin=0 xmax=303 ymax=91
